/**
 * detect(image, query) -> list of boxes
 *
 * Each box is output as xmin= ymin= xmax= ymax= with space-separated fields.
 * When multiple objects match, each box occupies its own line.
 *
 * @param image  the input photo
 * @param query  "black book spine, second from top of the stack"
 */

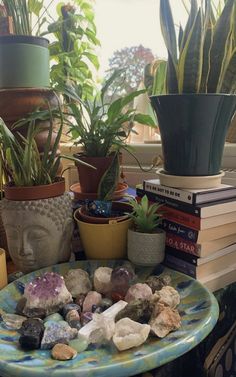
xmin=136 ymin=187 xmax=201 ymax=217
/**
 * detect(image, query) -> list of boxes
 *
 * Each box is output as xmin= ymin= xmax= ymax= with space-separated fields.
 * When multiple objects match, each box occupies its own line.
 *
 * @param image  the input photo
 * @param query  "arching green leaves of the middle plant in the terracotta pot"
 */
xmin=64 ymin=70 xmax=155 ymax=157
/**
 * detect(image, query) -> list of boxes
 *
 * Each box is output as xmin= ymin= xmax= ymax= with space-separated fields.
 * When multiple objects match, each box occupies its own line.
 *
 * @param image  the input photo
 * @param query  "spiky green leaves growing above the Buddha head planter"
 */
xmin=0 ymin=110 xmax=90 ymax=188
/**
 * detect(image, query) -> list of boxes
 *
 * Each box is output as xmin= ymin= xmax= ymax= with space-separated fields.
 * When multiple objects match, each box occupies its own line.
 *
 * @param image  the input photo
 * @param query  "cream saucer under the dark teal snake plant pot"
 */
xmin=157 ymin=169 xmax=225 ymax=189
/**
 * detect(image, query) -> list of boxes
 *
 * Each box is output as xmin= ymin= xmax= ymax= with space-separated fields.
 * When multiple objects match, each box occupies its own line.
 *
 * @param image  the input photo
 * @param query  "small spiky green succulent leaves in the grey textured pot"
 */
xmin=129 ymin=195 xmax=162 ymax=233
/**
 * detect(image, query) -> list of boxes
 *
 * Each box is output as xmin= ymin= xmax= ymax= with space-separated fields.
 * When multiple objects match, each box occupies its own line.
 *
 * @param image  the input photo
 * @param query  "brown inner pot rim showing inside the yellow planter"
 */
xmin=78 ymin=202 xmax=132 ymax=224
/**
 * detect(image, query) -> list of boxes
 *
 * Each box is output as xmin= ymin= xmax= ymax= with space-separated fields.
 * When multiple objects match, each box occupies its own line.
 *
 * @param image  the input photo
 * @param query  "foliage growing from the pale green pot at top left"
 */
xmin=1 ymin=0 xmax=49 ymax=35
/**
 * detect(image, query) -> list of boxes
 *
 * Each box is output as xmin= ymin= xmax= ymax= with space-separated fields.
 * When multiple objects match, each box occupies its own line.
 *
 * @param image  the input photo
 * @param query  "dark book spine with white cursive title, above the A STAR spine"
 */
xmin=160 ymin=219 xmax=199 ymax=242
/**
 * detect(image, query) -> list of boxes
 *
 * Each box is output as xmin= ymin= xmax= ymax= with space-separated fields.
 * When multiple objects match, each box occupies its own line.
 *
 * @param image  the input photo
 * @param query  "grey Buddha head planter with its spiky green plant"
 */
xmin=0 ymin=111 xmax=93 ymax=272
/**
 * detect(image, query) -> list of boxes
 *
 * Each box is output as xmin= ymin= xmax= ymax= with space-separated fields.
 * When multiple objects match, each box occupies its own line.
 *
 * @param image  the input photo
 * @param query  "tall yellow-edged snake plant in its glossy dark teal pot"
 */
xmin=151 ymin=0 xmax=236 ymax=176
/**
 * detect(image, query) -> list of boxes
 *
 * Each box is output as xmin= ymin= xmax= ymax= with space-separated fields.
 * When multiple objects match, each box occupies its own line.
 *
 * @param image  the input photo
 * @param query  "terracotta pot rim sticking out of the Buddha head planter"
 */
xmin=4 ymin=178 xmax=65 ymax=201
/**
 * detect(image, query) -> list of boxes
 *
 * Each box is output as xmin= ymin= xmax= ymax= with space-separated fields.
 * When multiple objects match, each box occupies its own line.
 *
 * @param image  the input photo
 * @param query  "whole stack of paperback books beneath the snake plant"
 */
xmin=136 ymin=179 xmax=236 ymax=292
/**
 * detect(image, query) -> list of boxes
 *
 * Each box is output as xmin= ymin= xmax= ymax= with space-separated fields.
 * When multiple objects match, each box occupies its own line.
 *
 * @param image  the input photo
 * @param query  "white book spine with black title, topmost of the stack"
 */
xmin=143 ymin=180 xmax=195 ymax=204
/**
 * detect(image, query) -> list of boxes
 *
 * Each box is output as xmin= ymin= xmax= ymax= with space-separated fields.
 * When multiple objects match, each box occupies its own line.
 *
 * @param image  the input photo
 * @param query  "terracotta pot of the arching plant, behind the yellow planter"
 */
xmin=74 ymin=153 xmax=121 ymax=193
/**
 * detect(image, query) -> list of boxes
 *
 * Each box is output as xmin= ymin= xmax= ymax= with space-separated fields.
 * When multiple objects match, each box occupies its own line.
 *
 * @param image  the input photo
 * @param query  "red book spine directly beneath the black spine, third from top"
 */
xmin=161 ymin=205 xmax=201 ymax=230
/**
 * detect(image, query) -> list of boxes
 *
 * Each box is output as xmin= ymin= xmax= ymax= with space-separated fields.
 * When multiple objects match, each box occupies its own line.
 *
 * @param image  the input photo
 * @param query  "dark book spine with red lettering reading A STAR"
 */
xmin=166 ymin=232 xmax=201 ymax=257
